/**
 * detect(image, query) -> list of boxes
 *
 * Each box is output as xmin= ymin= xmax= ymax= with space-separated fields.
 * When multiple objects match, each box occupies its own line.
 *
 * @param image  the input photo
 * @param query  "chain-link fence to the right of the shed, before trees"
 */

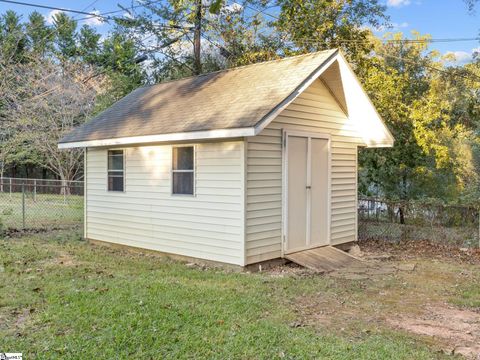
xmin=358 ymin=198 xmax=480 ymax=247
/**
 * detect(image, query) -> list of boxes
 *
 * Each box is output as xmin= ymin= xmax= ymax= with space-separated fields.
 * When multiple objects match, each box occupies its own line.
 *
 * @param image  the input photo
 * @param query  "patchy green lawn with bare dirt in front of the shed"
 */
xmin=0 ymin=231 xmax=480 ymax=359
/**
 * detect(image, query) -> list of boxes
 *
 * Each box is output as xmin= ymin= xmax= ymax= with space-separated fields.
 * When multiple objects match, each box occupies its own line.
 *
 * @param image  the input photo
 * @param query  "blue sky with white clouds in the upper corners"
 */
xmin=0 ymin=0 xmax=480 ymax=63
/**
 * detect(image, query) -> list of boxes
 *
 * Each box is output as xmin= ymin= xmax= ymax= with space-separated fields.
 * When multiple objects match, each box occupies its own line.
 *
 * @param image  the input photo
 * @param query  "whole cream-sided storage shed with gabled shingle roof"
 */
xmin=59 ymin=50 xmax=393 ymax=266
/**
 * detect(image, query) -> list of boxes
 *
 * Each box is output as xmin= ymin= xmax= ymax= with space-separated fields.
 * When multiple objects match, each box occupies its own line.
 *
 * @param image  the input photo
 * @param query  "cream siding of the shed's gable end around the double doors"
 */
xmin=246 ymin=80 xmax=363 ymax=264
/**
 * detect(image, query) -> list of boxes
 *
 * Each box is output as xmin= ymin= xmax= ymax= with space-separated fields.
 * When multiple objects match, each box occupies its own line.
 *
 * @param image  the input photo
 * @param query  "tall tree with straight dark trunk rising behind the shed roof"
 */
xmin=118 ymin=0 xmax=280 ymax=82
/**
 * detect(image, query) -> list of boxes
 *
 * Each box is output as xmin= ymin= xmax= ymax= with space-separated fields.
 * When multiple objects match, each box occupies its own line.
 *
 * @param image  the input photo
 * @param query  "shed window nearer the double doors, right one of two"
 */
xmin=172 ymin=146 xmax=195 ymax=195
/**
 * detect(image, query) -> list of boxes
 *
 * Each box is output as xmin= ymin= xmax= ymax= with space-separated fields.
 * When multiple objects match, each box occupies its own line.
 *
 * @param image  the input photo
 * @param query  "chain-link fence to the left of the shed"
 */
xmin=0 ymin=177 xmax=83 ymax=231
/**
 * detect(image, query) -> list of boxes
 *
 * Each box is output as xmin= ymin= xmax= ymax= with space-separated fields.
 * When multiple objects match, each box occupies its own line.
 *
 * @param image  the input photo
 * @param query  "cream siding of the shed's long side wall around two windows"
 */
xmin=86 ymin=141 xmax=245 ymax=265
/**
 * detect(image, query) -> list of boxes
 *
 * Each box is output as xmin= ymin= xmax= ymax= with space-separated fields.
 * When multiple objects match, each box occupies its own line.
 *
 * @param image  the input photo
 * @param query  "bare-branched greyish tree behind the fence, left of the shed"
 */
xmin=7 ymin=59 xmax=103 ymax=185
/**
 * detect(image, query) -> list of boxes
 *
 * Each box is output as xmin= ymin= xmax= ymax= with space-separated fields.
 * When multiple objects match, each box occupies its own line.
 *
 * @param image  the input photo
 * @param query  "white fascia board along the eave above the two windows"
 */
xmin=58 ymin=127 xmax=255 ymax=149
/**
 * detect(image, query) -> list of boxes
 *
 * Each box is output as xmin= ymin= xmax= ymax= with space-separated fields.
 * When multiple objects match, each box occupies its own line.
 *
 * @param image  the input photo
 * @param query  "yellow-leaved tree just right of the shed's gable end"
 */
xmin=360 ymin=33 xmax=479 ymax=201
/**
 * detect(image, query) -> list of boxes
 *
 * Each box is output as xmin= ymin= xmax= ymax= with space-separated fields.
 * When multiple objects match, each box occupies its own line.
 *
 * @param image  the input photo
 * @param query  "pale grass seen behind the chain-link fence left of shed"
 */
xmin=0 ymin=193 xmax=83 ymax=229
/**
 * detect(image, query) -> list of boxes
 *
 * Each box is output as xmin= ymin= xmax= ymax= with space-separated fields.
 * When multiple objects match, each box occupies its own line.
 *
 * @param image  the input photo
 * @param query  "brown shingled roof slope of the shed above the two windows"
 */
xmin=59 ymin=50 xmax=396 ymax=148
